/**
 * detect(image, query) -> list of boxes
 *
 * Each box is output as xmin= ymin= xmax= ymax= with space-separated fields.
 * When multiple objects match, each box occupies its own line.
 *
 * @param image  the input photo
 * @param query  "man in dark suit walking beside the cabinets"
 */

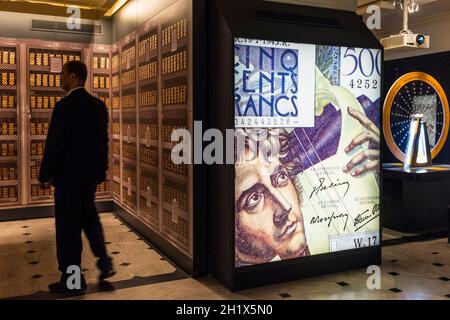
xmin=39 ymin=61 xmax=115 ymax=292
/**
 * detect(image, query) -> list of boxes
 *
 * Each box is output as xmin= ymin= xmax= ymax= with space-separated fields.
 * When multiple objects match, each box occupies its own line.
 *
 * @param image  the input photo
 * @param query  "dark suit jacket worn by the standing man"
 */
xmin=39 ymin=88 xmax=108 ymax=188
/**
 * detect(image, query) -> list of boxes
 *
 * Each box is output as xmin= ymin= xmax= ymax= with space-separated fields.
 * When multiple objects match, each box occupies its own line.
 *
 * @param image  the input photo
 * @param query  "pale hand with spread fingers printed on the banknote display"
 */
xmin=342 ymin=107 xmax=380 ymax=177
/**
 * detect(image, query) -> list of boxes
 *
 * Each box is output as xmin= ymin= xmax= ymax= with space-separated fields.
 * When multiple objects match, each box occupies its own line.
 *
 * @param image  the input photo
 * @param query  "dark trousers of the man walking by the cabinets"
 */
xmin=55 ymin=185 xmax=107 ymax=273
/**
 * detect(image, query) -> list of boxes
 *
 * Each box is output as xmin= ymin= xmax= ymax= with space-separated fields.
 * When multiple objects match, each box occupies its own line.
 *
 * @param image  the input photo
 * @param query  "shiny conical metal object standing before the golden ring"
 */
xmin=404 ymin=114 xmax=432 ymax=169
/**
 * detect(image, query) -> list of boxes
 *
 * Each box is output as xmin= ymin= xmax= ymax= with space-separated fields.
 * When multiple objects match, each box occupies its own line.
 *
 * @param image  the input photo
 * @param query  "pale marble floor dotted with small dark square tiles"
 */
xmin=0 ymin=214 xmax=450 ymax=300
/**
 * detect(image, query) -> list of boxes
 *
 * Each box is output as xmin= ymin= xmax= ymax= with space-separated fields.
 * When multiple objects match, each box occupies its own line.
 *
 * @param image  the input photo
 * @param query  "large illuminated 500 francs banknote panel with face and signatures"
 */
xmin=234 ymin=38 xmax=382 ymax=267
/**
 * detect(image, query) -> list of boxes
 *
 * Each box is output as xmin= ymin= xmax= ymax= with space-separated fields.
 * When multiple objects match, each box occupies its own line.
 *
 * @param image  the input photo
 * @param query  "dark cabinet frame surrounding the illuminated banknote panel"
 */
xmin=208 ymin=0 xmax=383 ymax=290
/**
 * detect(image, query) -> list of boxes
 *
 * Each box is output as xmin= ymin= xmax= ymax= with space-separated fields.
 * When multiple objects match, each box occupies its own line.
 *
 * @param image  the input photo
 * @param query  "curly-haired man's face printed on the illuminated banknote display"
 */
xmin=235 ymin=129 xmax=309 ymax=266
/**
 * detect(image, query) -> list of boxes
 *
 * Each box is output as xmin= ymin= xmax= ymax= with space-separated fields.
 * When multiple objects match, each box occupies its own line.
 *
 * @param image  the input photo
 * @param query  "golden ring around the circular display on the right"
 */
xmin=383 ymin=72 xmax=450 ymax=162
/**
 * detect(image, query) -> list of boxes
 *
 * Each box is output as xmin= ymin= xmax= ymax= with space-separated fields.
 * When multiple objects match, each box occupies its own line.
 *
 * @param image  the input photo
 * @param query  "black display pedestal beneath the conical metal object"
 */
xmin=381 ymin=164 xmax=450 ymax=232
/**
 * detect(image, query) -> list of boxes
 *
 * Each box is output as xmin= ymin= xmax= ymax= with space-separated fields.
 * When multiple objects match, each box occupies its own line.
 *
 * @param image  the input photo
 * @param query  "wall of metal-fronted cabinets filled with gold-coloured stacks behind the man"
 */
xmin=0 ymin=1 xmax=192 ymax=256
